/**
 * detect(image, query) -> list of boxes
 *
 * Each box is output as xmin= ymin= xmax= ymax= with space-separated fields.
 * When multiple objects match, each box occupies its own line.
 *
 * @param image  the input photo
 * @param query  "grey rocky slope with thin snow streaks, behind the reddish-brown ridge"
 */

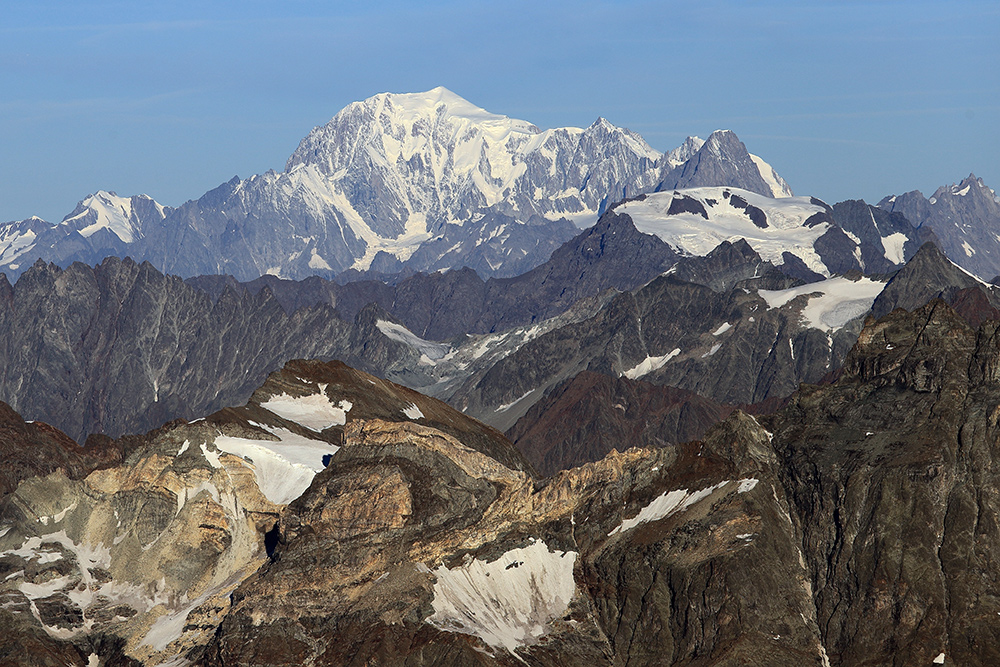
xmin=458 ymin=272 xmax=868 ymax=429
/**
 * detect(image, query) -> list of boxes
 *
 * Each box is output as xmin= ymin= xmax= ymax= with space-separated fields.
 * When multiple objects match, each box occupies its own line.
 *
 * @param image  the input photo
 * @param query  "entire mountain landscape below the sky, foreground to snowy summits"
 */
xmin=0 ymin=88 xmax=1000 ymax=667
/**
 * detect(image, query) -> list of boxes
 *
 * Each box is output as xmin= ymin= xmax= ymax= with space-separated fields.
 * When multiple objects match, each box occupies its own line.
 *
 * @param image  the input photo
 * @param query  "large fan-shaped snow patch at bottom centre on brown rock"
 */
xmin=427 ymin=540 xmax=577 ymax=655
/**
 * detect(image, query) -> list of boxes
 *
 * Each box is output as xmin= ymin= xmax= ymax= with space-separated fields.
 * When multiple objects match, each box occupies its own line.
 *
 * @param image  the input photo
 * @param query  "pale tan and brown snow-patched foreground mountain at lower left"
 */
xmin=0 ymin=361 xmax=533 ymax=665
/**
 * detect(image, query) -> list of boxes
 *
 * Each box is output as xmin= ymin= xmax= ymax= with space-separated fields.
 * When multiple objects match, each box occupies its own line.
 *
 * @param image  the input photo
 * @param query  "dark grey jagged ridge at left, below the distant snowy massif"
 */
xmin=0 ymin=259 xmax=438 ymax=441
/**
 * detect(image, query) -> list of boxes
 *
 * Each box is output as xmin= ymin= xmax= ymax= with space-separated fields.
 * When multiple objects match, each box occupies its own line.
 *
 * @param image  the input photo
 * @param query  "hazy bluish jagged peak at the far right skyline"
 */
xmin=878 ymin=174 xmax=1000 ymax=280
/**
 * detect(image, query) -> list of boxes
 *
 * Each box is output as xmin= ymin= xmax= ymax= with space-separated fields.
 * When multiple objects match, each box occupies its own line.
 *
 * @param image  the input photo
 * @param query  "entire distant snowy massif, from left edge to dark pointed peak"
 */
xmin=0 ymin=88 xmax=791 ymax=280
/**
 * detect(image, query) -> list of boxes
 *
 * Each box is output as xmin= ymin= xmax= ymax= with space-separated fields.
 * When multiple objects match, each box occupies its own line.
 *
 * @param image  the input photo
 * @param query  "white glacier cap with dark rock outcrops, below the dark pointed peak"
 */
xmin=615 ymin=187 xmax=864 ymax=278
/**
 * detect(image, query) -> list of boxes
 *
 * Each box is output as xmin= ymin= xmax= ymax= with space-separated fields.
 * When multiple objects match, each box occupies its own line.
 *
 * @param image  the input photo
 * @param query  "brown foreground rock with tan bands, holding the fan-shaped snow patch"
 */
xmin=206 ymin=408 xmax=822 ymax=665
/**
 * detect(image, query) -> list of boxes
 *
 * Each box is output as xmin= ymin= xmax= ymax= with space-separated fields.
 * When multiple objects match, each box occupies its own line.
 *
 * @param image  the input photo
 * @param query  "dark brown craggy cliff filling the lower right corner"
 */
xmin=766 ymin=301 xmax=1000 ymax=665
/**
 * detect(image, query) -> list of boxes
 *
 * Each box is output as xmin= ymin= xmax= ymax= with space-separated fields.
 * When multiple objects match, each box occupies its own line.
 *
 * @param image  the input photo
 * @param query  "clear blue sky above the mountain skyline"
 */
xmin=0 ymin=0 xmax=1000 ymax=222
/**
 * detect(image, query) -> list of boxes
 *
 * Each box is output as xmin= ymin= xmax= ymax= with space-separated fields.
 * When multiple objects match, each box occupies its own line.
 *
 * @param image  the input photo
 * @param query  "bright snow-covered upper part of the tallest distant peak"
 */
xmin=285 ymin=88 xmax=660 ymax=237
